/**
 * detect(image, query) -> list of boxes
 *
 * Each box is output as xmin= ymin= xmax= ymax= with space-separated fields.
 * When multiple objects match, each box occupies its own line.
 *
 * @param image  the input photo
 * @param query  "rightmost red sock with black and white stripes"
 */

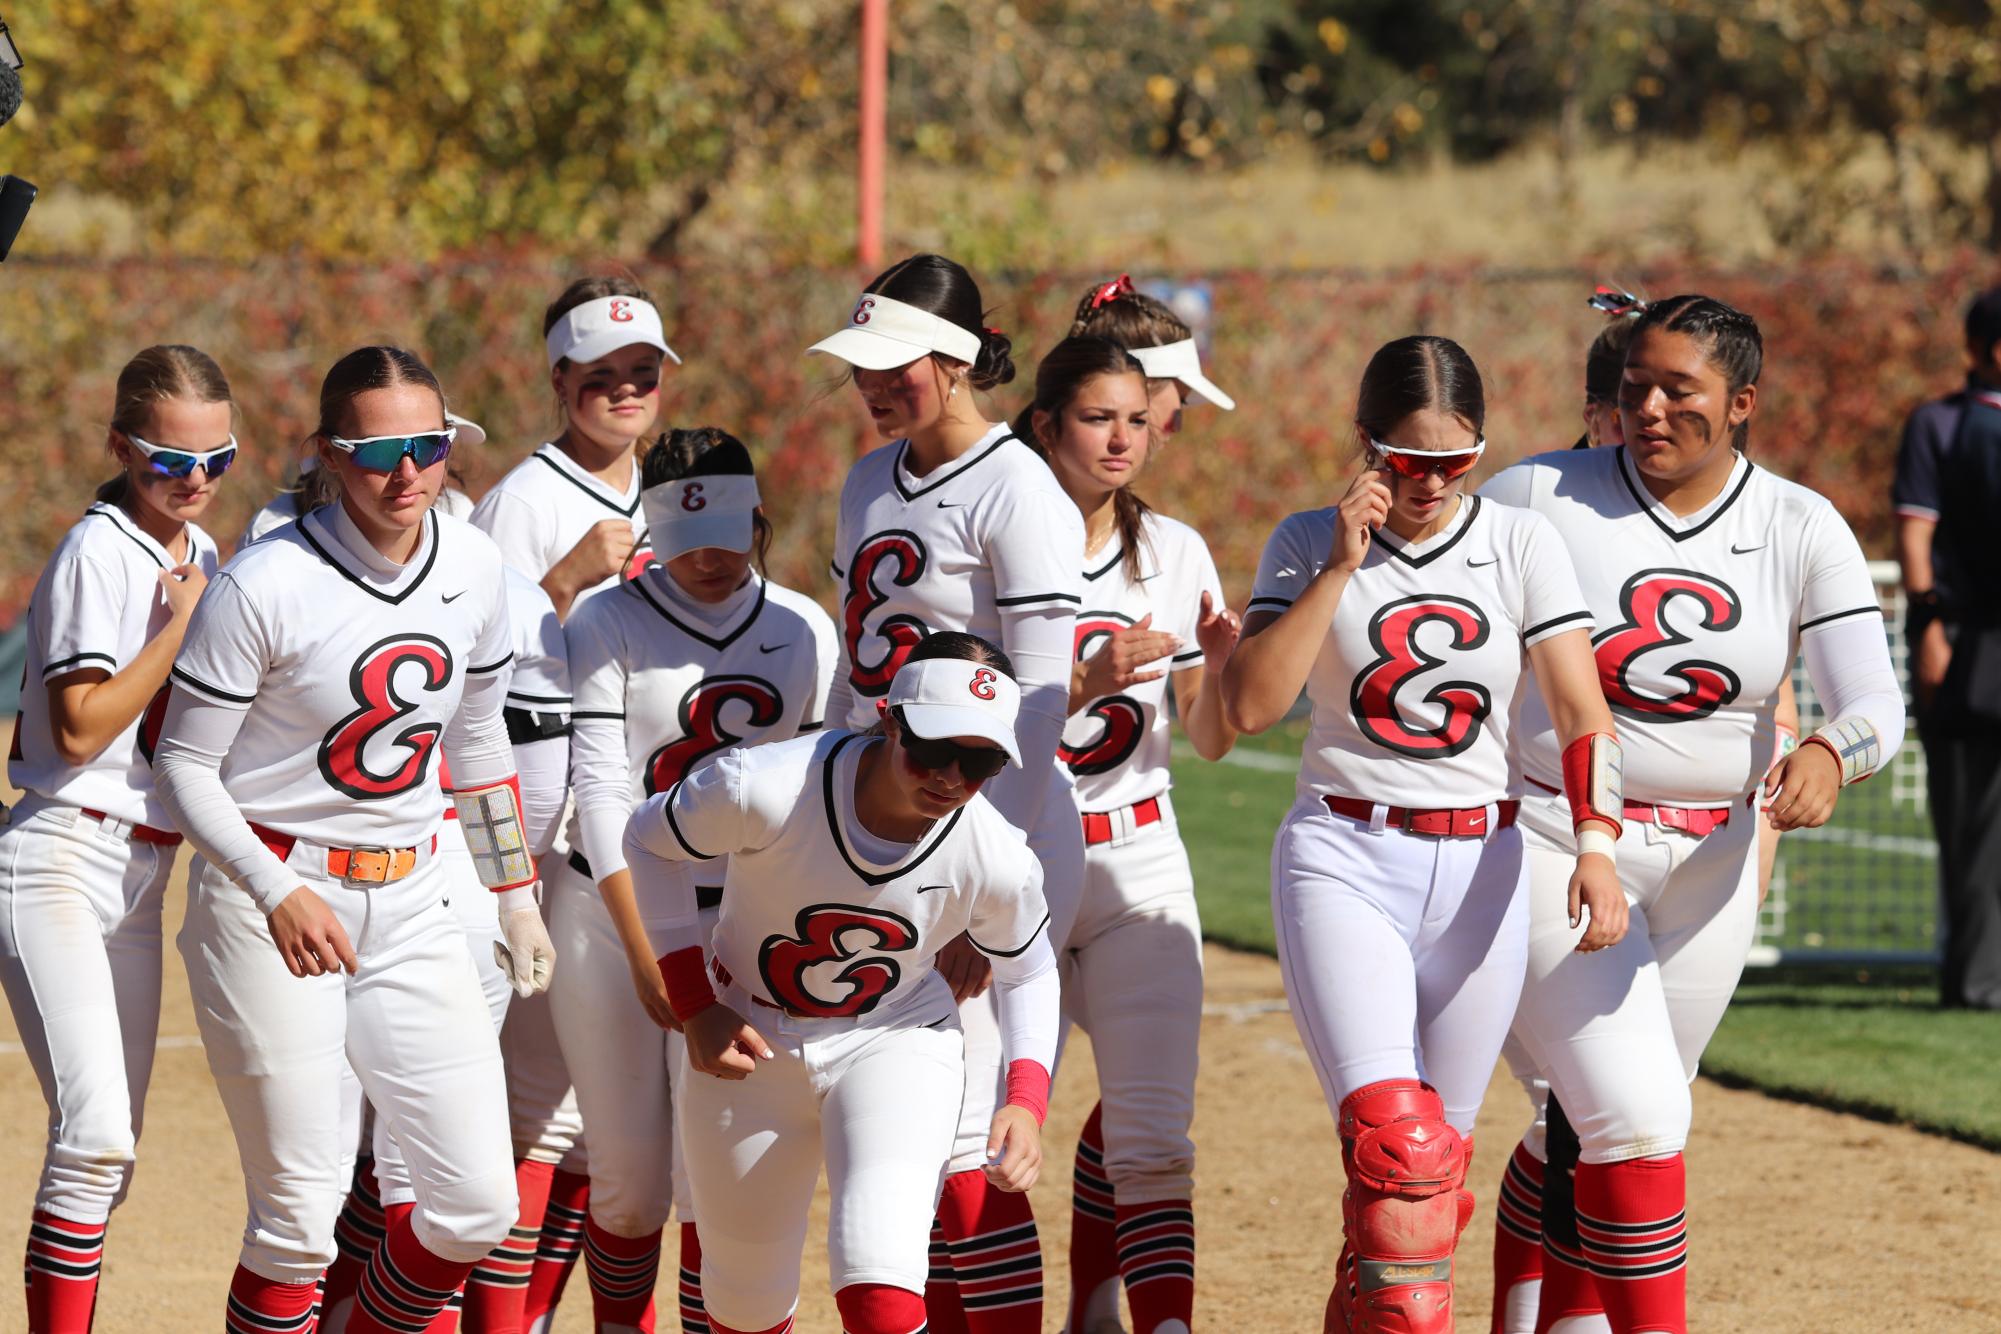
xmin=1577 ymin=1154 xmax=1689 ymax=1334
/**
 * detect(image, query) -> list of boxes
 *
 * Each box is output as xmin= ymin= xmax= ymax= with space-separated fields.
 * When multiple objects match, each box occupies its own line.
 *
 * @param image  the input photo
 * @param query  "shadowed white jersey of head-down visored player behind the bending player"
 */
xmin=564 ymin=566 xmax=838 ymax=884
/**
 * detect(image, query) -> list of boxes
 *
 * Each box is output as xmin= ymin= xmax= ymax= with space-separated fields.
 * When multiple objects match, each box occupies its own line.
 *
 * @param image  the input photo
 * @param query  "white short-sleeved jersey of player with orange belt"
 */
xmin=174 ymin=506 xmax=512 ymax=848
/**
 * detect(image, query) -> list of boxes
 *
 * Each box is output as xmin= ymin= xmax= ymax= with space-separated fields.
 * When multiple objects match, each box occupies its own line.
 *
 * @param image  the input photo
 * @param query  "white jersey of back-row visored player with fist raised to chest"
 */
xmin=472 ymin=444 xmax=652 ymax=610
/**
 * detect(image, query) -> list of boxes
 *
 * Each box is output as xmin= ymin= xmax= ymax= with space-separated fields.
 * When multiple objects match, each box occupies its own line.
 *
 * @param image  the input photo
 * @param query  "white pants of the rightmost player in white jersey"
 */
xmin=1515 ymin=794 xmax=1757 ymax=1162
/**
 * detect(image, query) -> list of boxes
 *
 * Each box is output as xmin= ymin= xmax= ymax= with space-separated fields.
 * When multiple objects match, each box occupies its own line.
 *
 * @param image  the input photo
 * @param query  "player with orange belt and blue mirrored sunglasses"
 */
xmin=158 ymin=348 xmax=552 ymax=1334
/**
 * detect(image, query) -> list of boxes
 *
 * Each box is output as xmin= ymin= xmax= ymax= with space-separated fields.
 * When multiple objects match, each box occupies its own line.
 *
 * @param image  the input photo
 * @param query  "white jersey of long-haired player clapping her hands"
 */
xmin=1057 ymin=514 xmax=1227 ymax=812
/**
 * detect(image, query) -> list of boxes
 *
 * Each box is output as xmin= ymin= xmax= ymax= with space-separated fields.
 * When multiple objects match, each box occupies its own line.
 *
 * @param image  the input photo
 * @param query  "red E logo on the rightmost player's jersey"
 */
xmin=1591 ymin=570 xmax=1743 ymax=722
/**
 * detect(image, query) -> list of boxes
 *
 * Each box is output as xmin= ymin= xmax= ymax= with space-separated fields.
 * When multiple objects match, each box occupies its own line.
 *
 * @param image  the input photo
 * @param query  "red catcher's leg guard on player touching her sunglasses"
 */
xmin=1341 ymin=1080 xmax=1471 ymax=1334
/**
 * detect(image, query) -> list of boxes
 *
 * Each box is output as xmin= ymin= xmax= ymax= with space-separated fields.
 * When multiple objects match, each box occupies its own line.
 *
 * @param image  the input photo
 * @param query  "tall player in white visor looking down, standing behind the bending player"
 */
xmin=812 ymin=254 xmax=1085 ymax=1334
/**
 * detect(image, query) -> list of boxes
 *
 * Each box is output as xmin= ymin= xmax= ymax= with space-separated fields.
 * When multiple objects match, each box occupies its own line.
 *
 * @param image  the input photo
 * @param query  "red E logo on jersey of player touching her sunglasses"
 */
xmin=1349 ymin=594 xmax=1493 ymax=760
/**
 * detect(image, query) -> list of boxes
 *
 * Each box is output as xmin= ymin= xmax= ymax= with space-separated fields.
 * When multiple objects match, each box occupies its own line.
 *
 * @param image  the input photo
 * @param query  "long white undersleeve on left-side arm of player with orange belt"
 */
xmin=152 ymin=686 xmax=300 ymax=914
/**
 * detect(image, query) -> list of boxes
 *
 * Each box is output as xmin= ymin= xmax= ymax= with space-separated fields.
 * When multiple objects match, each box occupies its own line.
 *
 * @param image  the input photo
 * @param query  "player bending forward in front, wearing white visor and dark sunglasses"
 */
xmin=626 ymin=634 xmax=1059 ymax=1334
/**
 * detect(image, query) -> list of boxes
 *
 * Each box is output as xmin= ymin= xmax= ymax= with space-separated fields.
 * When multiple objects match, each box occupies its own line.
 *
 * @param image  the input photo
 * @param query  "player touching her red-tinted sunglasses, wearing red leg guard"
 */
xmin=1225 ymin=336 xmax=1625 ymax=1334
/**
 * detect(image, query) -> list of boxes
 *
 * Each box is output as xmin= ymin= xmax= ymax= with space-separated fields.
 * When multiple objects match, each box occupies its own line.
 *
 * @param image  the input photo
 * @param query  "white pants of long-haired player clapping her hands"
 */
xmin=1063 ymin=794 xmax=1203 ymax=1204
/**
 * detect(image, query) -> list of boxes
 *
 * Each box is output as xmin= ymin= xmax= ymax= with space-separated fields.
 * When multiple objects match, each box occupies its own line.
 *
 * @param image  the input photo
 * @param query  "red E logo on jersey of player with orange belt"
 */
xmin=318 ymin=634 xmax=452 ymax=802
